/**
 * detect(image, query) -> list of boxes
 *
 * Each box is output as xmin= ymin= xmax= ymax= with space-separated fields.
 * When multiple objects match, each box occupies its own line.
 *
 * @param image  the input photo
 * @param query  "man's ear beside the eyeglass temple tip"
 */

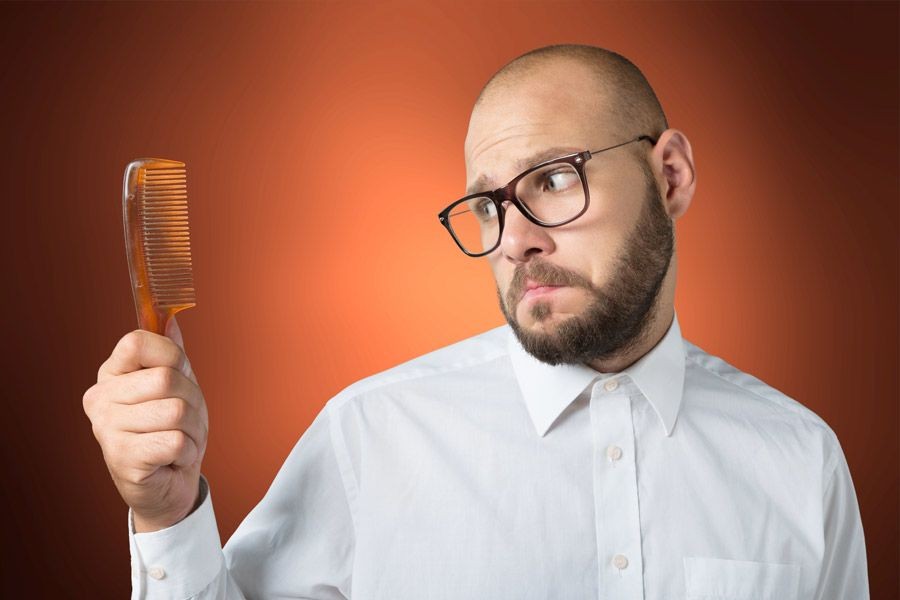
xmin=650 ymin=129 xmax=697 ymax=219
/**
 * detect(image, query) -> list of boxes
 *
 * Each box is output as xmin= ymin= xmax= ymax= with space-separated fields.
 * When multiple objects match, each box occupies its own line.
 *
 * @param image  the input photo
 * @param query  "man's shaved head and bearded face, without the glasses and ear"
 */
xmin=466 ymin=45 xmax=690 ymax=371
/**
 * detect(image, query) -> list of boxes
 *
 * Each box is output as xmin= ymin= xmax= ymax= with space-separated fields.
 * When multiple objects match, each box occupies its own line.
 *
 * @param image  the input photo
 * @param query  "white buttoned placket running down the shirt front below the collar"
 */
xmin=590 ymin=376 xmax=644 ymax=600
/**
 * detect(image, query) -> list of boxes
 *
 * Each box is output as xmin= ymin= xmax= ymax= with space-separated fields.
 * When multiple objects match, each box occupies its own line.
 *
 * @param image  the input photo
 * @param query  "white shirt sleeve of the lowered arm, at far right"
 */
xmin=816 ymin=438 xmax=869 ymax=600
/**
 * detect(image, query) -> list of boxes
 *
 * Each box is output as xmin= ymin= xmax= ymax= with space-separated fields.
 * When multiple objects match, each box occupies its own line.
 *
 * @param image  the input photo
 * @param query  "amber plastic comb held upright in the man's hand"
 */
xmin=122 ymin=158 xmax=197 ymax=335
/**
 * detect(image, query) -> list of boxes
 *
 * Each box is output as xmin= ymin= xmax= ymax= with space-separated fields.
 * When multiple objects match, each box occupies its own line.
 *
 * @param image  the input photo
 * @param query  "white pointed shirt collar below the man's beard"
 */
xmin=508 ymin=315 xmax=684 ymax=437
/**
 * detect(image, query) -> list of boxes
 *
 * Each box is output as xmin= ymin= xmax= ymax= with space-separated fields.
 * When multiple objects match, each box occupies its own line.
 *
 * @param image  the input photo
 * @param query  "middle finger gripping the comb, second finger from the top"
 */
xmin=89 ymin=367 xmax=203 ymax=408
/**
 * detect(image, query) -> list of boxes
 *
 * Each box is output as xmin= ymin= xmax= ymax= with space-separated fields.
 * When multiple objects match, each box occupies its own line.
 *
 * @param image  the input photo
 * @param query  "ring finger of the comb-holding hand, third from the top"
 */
xmin=107 ymin=398 xmax=207 ymax=448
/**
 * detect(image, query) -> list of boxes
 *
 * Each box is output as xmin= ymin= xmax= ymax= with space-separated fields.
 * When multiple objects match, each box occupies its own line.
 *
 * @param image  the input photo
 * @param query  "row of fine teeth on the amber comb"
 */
xmin=137 ymin=167 xmax=195 ymax=308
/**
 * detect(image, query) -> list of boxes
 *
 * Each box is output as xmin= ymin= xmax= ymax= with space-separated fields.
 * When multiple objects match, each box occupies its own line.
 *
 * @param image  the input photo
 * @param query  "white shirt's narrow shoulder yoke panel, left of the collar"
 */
xmin=326 ymin=325 xmax=509 ymax=411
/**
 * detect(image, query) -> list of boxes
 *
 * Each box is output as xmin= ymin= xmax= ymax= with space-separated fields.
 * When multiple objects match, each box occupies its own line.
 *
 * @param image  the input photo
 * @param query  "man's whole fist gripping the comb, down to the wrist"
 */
xmin=82 ymin=317 xmax=209 ymax=533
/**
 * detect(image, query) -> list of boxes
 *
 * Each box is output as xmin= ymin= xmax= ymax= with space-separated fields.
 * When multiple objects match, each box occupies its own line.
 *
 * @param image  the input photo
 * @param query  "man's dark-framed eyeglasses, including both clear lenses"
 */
xmin=438 ymin=135 xmax=656 ymax=257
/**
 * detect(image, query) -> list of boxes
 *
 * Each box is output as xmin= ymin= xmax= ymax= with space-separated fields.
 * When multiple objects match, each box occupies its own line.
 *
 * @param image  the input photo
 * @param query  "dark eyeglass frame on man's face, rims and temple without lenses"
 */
xmin=438 ymin=135 xmax=657 ymax=258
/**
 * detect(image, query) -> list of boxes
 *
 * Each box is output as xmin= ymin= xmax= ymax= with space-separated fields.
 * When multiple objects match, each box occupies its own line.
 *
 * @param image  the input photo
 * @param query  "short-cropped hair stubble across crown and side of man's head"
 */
xmin=475 ymin=44 xmax=668 ymax=137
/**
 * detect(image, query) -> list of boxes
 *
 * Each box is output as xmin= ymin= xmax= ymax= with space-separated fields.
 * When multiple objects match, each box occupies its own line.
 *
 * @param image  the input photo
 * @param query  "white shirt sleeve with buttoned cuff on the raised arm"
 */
xmin=129 ymin=410 xmax=354 ymax=600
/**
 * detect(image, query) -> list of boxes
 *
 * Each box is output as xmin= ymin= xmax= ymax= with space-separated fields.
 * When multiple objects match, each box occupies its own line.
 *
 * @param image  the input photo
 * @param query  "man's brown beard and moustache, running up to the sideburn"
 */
xmin=497 ymin=165 xmax=675 ymax=365
